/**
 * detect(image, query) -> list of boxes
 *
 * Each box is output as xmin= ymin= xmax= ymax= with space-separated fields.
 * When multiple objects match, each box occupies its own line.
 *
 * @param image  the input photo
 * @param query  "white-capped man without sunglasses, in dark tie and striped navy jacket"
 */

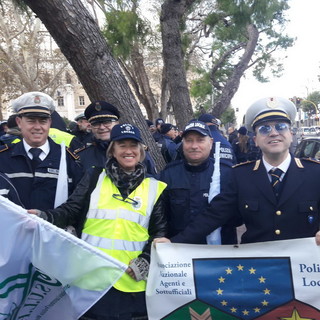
xmin=0 ymin=92 xmax=83 ymax=210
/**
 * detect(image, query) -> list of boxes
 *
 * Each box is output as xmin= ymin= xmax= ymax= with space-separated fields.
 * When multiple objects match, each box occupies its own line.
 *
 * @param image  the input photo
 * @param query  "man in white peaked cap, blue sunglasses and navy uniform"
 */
xmin=157 ymin=97 xmax=320 ymax=243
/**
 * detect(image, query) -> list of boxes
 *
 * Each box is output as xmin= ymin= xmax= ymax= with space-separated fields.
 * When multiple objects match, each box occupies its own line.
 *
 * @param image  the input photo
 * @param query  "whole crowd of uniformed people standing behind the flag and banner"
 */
xmin=0 ymin=92 xmax=320 ymax=320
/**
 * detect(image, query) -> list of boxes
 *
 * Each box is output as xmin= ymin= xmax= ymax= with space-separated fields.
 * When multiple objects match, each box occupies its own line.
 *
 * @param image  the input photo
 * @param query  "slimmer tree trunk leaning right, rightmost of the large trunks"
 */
xmin=213 ymin=24 xmax=259 ymax=118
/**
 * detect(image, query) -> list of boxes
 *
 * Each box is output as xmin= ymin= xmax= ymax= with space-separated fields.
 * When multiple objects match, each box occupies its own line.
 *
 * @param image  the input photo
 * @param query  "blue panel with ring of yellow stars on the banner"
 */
xmin=193 ymin=257 xmax=294 ymax=320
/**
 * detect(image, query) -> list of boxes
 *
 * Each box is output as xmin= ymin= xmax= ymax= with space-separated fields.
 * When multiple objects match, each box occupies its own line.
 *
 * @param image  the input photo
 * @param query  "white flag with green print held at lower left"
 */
xmin=0 ymin=196 xmax=127 ymax=320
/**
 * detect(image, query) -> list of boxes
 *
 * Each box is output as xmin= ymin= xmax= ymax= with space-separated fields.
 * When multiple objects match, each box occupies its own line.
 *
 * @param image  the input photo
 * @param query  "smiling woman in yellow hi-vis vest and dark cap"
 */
xmin=29 ymin=124 xmax=167 ymax=320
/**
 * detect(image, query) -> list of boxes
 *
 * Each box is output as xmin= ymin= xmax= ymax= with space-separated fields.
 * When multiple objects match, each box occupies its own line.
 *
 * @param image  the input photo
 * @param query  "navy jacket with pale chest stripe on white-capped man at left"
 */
xmin=0 ymin=138 xmax=83 ymax=210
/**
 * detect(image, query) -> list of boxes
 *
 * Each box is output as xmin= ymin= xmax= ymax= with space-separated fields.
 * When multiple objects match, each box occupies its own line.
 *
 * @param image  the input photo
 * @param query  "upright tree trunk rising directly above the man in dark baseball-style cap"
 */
xmin=160 ymin=0 xmax=193 ymax=128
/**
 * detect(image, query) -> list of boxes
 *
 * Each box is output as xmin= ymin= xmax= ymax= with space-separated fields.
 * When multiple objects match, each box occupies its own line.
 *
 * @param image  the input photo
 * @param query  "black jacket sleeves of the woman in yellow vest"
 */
xmin=45 ymin=168 xmax=167 ymax=261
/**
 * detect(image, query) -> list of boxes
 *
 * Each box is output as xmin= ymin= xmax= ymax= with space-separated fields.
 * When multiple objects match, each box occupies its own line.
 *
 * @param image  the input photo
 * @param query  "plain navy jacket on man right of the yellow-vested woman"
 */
xmin=160 ymin=158 xmax=237 ymax=244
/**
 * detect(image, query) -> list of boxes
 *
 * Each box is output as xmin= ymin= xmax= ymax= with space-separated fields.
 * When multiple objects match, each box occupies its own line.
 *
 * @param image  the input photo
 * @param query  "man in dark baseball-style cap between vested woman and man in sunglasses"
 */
xmin=160 ymin=120 xmax=237 ymax=244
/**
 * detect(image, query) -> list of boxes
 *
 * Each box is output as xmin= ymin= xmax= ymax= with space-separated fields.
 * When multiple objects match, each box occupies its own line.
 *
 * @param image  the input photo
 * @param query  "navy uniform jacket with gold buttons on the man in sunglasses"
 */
xmin=171 ymin=158 xmax=320 ymax=243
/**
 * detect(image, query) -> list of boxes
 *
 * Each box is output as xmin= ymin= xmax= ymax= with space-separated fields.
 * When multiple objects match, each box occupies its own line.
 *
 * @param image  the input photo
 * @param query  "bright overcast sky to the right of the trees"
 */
xmin=232 ymin=0 xmax=320 ymax=125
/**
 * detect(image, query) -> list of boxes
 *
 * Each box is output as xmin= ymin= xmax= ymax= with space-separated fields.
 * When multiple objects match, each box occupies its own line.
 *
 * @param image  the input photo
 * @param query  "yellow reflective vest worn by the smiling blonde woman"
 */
xmin=82 ymin=170 xmax=166 ymax=292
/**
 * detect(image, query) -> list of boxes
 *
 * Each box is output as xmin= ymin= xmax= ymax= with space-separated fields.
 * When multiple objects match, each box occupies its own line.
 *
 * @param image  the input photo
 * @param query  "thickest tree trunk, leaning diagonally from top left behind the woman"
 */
xmin=24 ymin=0 xmax=164 ymax=168
